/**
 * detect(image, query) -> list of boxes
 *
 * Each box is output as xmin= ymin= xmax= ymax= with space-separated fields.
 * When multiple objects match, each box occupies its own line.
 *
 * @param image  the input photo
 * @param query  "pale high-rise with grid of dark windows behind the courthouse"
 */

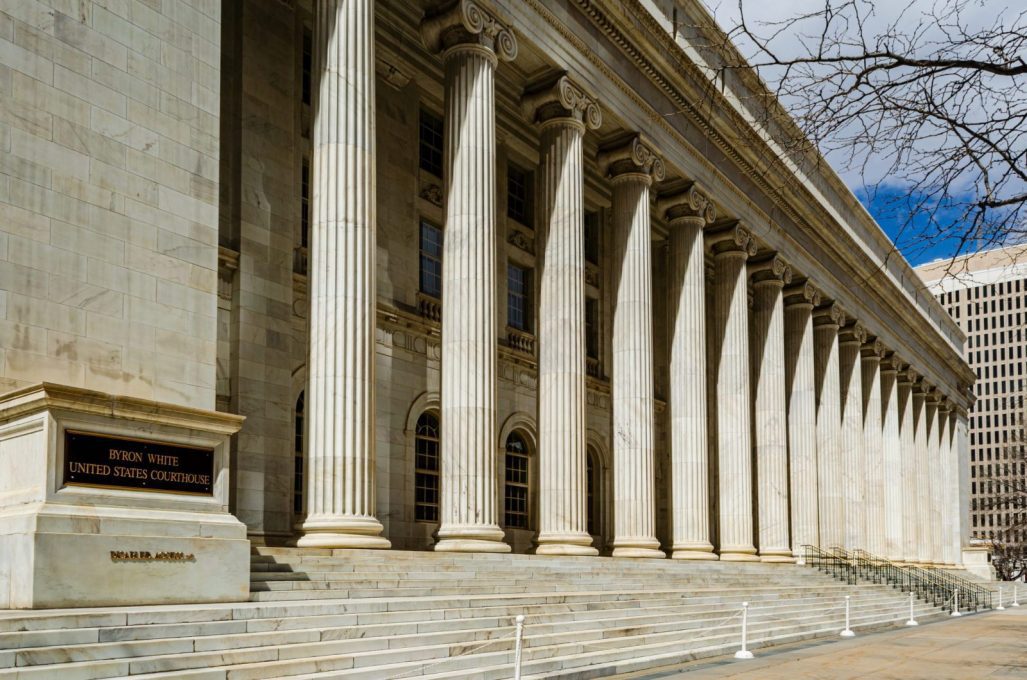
xmin=917 ymin=245 xmax=1027 ymax=542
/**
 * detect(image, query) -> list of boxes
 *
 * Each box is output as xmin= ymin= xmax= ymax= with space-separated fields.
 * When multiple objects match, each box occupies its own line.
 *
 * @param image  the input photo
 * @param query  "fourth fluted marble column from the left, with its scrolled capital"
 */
xmin=600 ymin=136 xmax=665 ymax=558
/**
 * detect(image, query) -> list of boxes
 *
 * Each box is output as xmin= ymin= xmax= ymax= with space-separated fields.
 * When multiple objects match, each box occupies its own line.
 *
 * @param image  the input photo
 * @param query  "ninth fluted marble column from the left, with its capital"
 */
xmin=813 ymin=304 xmax=845 ymax=549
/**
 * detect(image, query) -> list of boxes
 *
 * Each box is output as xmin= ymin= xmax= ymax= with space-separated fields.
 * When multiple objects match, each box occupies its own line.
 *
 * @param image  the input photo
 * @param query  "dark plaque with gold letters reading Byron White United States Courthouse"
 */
xmin=64 ymin=430 xmax=214 ymax=496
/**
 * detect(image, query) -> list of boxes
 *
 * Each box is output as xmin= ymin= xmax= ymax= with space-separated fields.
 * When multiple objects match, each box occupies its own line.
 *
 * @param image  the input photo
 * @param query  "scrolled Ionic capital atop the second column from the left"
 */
xmin=421 ymin=0 xmax=517 ymax=62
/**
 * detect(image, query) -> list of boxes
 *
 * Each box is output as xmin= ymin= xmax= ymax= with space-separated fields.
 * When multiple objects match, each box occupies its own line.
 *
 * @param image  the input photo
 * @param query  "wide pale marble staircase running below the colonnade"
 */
xmin=0 ymin=547 xmax=945 ymax=680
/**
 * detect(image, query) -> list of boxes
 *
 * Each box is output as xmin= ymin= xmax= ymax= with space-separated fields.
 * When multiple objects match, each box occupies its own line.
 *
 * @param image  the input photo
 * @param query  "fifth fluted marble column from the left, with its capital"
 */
xmin=659 ymin=185 xmax=717 ymax=560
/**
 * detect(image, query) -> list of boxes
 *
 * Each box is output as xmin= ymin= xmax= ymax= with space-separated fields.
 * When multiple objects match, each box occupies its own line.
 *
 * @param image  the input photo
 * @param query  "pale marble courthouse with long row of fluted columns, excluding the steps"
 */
xmin=0 ymin=0 xmax=975 ymax=608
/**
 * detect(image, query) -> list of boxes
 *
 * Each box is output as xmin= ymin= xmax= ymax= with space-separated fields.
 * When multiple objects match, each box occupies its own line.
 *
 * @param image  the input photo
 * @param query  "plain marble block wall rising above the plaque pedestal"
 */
xmin=0 ymin=0 xmax=221 ymax=409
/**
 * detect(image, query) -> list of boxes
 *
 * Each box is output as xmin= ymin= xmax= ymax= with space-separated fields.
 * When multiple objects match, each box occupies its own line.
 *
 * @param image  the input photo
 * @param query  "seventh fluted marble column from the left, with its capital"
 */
xmin=749 ymin=256 xmax=795 ymax=562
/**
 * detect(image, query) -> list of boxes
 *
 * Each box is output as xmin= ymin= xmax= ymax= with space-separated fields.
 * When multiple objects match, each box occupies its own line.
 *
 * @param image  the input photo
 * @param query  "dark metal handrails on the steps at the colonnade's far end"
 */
xmin=803 ymin=545 xmax=992 ymax=611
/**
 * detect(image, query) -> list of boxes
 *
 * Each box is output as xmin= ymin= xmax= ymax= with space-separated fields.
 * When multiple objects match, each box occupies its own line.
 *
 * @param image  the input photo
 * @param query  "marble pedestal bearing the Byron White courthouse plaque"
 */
xmin=0 ymin=383 xmax=250 ymax=609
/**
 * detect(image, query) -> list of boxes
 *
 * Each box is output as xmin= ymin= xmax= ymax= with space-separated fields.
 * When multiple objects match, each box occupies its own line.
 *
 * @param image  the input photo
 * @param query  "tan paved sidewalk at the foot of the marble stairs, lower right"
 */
xmin=625 ymin=605 xmax=1027 ymax=680
